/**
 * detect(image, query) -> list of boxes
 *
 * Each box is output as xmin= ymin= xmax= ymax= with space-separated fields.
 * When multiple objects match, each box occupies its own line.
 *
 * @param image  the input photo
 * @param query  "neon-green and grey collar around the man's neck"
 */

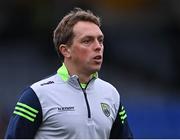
xmin=57 ymin=63 xmax=98 ymax=88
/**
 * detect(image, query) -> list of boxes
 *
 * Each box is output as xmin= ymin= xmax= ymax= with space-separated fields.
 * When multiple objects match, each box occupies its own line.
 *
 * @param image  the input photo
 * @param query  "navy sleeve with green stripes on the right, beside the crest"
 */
xmin=110 ymin=103 xmax=133 ymax=139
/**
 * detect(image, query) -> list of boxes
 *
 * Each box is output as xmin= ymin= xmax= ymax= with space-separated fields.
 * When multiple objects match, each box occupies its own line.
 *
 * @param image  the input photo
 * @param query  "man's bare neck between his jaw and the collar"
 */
xmin=64 ymin=61 xmax=92 ymax=83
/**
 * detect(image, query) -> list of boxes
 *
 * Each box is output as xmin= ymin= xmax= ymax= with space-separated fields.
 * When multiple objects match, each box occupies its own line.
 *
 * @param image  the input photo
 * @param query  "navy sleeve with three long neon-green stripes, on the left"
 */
xmin=5 ymin=87 xmax=42 ymax=139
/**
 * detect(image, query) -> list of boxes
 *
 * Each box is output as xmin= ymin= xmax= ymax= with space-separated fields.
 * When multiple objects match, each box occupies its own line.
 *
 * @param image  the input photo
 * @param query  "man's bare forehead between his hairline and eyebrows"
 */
xmin=73 ymin=21 xmax=103 ymax=37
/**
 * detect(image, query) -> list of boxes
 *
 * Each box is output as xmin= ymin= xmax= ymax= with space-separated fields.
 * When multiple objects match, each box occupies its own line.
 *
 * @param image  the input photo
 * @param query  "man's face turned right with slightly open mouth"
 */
xmin=69 ymin=21 xmax=104 ymax=74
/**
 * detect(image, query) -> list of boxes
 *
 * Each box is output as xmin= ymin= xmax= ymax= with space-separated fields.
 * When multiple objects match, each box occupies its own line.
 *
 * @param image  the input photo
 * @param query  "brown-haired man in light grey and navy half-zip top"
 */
xmin=5 ymin=8 xmax=132 ymax=139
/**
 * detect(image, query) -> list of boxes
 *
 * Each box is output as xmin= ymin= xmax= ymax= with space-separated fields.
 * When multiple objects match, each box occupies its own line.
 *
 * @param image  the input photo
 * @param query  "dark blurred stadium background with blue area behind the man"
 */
xmin=0 ymin=0 xmax=180 ymax=139
